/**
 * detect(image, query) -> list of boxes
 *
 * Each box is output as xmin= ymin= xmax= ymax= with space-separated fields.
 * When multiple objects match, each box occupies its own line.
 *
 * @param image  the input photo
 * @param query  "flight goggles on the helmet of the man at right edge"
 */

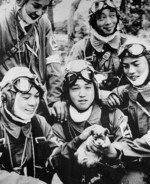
xmin=118 ymin=43 xmax=150 ymax=58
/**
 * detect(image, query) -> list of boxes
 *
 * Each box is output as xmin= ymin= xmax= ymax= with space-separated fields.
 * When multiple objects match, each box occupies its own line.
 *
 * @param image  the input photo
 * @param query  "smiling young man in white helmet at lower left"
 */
xmin=0 ymin=67 xmax=59 ymax=184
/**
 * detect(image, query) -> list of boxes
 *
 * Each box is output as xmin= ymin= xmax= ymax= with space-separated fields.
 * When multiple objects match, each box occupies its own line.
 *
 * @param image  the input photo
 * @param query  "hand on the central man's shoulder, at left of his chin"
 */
xmin=50 ymin=101 xmax=68 ymax=123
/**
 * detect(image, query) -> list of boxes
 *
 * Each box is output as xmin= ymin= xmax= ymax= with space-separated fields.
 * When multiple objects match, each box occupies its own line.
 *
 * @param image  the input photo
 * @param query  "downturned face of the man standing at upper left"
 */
xmin=25 ymin=0 xmax=50 ymax=20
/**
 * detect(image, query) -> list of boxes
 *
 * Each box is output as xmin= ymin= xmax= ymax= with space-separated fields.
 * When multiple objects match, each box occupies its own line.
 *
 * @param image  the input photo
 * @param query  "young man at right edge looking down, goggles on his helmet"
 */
xmin=108 ymin=37 xmax=150 ymax=184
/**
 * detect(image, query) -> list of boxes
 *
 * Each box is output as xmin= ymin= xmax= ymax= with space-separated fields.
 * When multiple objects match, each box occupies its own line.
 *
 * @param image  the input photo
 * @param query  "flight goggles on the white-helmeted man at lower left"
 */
xmin=8 ymin=77 xmax=44 ymax=94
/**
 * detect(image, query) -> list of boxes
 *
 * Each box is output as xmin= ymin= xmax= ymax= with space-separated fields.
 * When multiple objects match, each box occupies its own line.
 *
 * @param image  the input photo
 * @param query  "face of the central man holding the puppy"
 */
xmin=69 ymin=79 xmax=95 ymax=111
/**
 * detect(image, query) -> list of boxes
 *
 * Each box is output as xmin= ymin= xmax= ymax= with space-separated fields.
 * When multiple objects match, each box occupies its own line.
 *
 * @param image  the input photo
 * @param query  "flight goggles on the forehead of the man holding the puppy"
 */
xmin=65 ymin=68 xmax=94 ymax=85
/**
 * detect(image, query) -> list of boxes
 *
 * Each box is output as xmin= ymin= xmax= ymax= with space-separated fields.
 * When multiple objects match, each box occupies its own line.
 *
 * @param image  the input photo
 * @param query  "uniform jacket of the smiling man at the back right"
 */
xmin=68 ymin=33 xmax=126 ymax=90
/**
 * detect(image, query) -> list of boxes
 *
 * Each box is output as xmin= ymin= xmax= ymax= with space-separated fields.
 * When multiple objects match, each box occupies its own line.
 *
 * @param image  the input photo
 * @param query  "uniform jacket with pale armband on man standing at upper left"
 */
xmin=0 ymin=4 xmax=62 ymax=104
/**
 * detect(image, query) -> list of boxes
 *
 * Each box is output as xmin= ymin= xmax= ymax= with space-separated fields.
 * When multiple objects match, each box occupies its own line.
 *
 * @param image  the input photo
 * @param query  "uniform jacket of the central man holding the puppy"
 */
xmin=53 ymin=105 xmax=131 ymax=184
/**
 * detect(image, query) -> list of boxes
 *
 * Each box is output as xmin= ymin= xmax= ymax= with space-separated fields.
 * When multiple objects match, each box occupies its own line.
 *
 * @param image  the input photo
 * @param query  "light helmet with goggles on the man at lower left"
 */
xmin=0 ymin=66 xmax=44 ymax=111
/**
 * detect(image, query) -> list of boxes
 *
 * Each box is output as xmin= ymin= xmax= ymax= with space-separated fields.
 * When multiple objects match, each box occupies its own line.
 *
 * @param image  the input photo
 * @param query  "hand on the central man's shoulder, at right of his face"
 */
xmin=107 ymin=93 xmax=122 ymax=108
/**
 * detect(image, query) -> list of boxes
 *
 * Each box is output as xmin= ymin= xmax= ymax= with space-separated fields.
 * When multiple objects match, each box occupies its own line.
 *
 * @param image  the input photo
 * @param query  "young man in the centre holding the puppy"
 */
xmin=52 ymin=60 xmax=131 ymax=184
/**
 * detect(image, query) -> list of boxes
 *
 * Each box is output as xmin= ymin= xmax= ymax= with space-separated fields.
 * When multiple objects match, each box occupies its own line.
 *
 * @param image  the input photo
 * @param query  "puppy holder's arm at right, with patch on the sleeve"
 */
xmin=98 ymin=109 xmax=132 ymax=158
